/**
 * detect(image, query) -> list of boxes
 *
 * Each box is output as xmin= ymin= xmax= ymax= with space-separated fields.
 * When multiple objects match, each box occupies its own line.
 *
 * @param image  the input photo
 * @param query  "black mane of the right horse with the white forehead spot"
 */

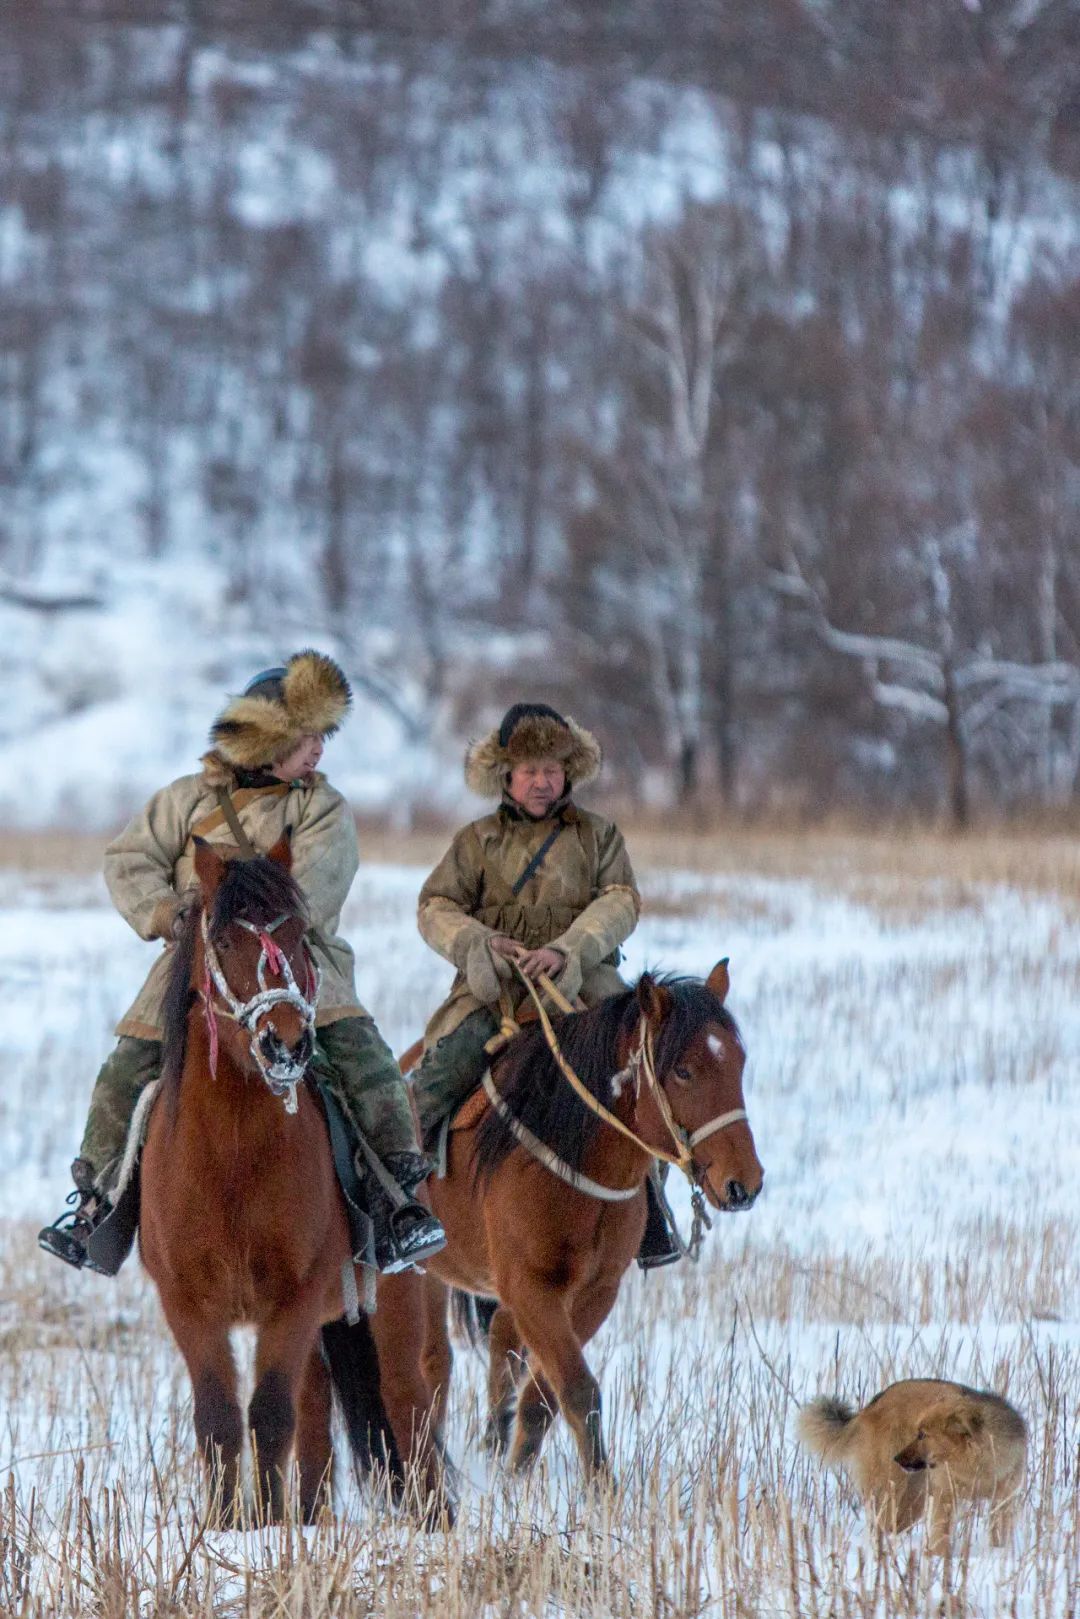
xmin=476 ymin=973 xmax=738 ymax=1183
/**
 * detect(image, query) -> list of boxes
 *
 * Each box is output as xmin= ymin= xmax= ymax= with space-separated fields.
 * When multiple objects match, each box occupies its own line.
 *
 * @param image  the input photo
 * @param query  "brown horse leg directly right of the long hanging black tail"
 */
xmin=371 ymin=1271 xmax=453 ymax=1527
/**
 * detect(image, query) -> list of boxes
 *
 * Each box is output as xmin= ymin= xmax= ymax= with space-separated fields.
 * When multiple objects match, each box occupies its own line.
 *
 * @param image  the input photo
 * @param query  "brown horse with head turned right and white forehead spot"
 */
xmin=401 ymin=962 xmax=763 ymax=1475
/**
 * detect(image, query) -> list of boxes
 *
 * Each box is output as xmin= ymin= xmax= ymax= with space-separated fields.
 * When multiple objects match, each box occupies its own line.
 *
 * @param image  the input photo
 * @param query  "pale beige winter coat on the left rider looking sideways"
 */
xmin=105 ymin=753 xmax=366 ymax=1039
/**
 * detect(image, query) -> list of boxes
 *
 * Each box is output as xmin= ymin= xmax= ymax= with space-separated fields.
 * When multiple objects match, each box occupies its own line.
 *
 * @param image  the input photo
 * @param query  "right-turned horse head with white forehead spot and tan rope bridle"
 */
xmin=628 ymin=957 xmax=764 ymax=1211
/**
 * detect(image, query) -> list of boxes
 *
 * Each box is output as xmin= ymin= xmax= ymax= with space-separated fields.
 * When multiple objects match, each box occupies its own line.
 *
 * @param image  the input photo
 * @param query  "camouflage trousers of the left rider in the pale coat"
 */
xmin=79 ymin=1017 xmax=416 ymax=1187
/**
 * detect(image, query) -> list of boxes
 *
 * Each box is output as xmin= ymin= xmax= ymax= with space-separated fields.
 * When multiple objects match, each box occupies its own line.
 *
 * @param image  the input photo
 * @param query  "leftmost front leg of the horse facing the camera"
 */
xmin=162 ymin=1297 xmax=244 ymax=1525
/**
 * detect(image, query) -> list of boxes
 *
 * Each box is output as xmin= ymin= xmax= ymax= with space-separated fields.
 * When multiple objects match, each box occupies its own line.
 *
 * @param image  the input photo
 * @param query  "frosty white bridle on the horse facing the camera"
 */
xmin=199 ymin=911 xmax=322 ymax=1114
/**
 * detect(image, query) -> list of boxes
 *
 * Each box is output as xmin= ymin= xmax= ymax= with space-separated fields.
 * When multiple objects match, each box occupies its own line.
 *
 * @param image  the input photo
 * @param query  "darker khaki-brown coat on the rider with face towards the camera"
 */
xmin=418 ymin=805 xmax=641 ymax=1047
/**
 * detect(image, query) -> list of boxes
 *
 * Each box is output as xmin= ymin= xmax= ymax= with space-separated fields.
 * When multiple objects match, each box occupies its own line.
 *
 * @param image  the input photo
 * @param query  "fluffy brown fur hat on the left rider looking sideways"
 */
xmin=210 ymin=651 xmax=353 ymax=771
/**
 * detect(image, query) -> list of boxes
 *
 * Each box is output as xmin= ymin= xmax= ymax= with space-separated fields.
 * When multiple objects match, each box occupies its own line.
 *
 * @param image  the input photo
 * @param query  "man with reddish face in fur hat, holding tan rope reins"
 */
xmin=413 ymin=703 xmax=680 ymax=1266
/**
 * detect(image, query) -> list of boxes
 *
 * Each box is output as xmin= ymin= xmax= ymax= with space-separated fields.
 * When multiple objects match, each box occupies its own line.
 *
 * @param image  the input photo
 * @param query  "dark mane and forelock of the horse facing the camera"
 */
xmin=162 ymin=855 xmax=308 ymax=1117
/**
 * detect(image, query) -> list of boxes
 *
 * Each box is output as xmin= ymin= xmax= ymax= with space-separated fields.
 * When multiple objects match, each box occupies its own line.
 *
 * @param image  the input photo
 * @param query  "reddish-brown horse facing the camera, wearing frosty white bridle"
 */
xmin=139 ymin=839 xmax=449 ymax=1522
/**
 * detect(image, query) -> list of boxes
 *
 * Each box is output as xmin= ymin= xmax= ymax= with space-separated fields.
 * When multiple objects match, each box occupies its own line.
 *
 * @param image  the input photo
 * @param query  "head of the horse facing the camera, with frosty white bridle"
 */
xmin=193 ymin=832 xmax=319 ymax=1112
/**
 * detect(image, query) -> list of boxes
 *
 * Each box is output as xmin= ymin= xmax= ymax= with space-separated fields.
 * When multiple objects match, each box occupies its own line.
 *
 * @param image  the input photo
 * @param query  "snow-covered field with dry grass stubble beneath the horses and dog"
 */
xmin=0 ymin=840 xmax=1080 ymax=1619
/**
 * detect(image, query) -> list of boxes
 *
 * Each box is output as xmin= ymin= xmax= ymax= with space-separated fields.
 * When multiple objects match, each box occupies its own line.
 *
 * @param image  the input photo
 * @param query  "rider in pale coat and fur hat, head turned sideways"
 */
xmin=39 ymin=651 xmax=445 ymax=1271
